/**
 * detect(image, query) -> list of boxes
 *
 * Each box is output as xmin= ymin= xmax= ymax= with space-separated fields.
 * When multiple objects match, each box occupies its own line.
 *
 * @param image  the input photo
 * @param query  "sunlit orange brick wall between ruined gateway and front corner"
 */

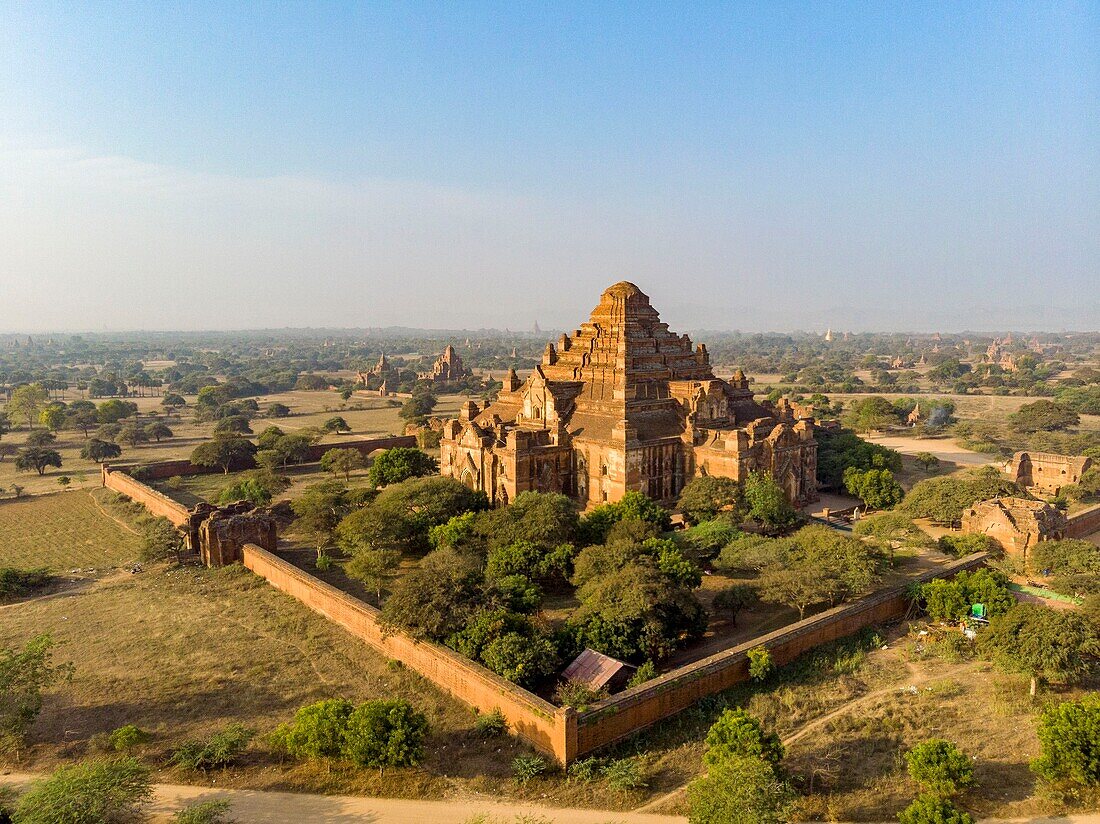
xmin=236 ymin=543 xmax=576 ymax=763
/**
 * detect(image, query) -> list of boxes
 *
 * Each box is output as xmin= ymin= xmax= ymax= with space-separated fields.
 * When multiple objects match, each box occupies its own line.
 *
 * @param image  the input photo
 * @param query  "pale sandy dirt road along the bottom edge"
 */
xmin=0 ymin=773 xmax=688 ymax=824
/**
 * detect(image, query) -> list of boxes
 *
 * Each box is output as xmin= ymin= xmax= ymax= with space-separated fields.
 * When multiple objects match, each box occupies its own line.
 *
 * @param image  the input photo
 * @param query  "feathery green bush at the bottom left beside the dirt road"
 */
xmin=12 ymin=758 xmax=153 ymax=824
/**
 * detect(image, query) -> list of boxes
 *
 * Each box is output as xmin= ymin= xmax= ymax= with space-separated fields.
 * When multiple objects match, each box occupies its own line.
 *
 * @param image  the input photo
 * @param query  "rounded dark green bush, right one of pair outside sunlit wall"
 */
xmin=343 ymin=699 xmax=428 ymax=776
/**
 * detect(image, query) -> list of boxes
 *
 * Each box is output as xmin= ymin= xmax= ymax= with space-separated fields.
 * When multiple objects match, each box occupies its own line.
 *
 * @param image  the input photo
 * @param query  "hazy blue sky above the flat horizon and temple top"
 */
xmin=0 ymin=2 xmax=1100 ymax=331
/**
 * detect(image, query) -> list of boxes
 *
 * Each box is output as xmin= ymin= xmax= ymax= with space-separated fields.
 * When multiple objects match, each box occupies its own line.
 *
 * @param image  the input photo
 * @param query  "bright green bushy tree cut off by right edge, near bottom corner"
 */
xmin=1032 ymin=692 xmax=1100 ymax=787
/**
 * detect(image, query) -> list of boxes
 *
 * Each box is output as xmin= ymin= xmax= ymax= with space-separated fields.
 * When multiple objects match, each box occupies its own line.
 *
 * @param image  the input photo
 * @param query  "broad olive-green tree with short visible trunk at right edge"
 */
xmin=978 ymin=604 xmax=1100 ymax=695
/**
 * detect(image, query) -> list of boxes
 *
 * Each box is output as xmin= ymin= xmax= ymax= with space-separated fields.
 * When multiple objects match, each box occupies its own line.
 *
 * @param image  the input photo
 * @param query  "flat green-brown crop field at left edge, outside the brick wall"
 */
xmin=0 ymin=490 xmax=141 ymax=572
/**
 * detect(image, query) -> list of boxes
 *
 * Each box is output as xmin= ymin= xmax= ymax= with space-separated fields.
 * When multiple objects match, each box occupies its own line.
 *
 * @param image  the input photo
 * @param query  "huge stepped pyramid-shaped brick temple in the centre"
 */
xmin=440 ymin=282 xmax=817 ymax=507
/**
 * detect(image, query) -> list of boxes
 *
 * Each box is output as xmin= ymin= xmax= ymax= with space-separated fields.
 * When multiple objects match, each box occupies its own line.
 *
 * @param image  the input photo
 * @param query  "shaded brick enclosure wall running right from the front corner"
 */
xmin=571 ymin=553 xmax=988 ymax=758
